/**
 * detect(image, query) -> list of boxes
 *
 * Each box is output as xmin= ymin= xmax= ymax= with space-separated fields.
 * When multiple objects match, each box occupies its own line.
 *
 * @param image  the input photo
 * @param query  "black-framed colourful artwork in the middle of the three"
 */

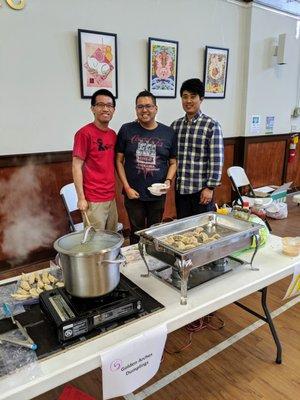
xmin=148 ymin=38 xmax=178 ymax=98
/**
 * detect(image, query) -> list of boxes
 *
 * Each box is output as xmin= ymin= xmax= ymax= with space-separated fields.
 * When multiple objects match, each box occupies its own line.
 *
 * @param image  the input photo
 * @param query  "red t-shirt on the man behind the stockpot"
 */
xmin=73 ymin=123 xmax=117 ymax=203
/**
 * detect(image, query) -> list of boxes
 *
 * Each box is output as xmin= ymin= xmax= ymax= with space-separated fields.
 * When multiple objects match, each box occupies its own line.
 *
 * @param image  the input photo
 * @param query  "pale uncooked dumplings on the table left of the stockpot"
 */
xmin=11 ymin=269 xmax=64 ymax=302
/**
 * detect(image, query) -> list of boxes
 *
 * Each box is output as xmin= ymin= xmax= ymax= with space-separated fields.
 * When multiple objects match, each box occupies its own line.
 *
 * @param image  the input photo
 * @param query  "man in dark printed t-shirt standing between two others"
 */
xmin=116 ymin=90 xmax=177 ymax=244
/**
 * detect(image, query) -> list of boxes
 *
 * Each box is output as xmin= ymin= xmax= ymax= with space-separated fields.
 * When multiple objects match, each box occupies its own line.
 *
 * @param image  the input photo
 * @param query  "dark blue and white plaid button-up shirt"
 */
xmin=171 ymin=111 xmax=224 ymax=194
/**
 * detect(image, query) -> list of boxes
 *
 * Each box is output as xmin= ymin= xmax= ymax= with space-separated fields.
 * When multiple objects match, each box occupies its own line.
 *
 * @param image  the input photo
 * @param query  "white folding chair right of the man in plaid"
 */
xmin=227 ymin=166 xmax=273 ymax=207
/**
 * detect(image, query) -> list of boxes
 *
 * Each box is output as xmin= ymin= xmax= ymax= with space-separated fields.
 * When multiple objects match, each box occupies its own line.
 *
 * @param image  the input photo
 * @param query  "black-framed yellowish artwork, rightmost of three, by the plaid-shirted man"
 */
xmin=203 ymin=46 xmax=229 ymax=99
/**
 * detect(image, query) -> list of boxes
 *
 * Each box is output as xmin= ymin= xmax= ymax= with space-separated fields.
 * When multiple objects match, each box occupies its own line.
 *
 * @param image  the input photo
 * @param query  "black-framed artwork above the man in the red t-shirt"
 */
xmin=78 ymin=29 xmax=118 ymax=99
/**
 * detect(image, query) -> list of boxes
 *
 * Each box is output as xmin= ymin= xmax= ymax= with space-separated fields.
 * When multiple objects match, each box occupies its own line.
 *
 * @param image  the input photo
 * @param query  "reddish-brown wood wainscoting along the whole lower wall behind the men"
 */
xmin=0 ymin=134 xmax=300 ymax=272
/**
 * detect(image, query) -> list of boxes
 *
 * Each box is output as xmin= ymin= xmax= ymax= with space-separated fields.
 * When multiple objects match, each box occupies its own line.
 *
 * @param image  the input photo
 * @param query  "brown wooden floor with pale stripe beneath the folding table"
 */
xmin=20 ymin=199 xmax=300 ymax=400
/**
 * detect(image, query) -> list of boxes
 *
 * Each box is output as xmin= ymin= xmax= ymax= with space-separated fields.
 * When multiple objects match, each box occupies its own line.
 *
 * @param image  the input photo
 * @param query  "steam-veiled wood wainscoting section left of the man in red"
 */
xmin=0 ymin=152 xmax=72 ymax=271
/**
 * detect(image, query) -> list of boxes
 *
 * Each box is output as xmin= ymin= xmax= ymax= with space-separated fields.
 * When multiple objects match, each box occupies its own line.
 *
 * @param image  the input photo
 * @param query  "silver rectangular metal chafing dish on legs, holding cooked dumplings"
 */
xmin=136 ymin=212 xmax=261 ymax=305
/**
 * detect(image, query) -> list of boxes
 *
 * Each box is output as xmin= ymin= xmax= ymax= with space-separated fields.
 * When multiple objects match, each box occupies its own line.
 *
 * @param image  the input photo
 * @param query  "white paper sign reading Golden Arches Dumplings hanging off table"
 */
xmin=101 ymin=325 xmax=167 ymax=400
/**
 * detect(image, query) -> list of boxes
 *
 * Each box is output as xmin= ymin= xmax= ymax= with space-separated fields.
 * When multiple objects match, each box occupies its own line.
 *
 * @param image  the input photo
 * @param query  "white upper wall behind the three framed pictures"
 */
xmin=0 ymin=0 xmax=298 ymax=155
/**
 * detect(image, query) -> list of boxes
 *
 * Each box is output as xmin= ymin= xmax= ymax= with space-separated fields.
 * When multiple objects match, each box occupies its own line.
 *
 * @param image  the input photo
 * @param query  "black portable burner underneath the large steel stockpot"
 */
xmin=40 ymin=274 xmax=163 ymax=342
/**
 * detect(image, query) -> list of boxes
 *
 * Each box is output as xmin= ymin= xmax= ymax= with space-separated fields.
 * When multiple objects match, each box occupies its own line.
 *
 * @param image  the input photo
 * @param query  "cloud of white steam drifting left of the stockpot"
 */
xmin=0 ymin=165 xmax=58 ymax=261
